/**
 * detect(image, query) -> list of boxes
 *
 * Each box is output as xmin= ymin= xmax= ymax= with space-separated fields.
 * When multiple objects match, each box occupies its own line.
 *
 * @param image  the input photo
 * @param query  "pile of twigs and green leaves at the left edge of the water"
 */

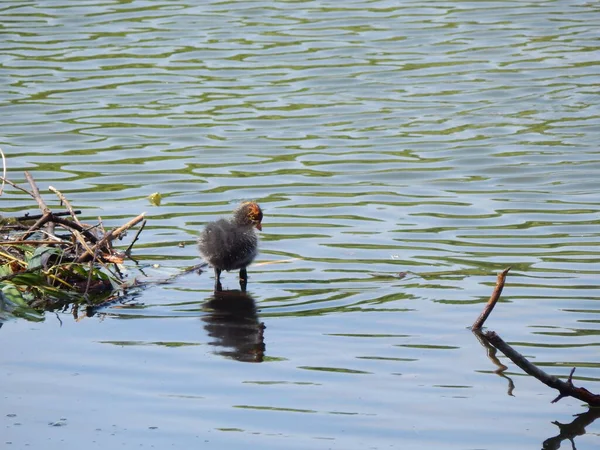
xmin=0 ymin=172 xmax=146 ymax=309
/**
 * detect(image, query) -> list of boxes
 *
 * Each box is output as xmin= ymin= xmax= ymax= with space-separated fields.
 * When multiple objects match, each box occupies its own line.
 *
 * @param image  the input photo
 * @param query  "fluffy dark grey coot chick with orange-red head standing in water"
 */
xmin=198 ymin=202 xmax=262 ymax=291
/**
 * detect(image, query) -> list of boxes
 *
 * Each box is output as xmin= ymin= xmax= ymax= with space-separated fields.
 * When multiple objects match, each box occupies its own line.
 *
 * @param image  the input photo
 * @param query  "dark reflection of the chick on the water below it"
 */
xmin=202 ymin=290 xmax=265 ymax=362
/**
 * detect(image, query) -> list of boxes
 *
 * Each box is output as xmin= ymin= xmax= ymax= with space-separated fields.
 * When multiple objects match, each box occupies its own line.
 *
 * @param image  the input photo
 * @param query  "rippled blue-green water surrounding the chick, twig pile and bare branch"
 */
xmin=0 ymin=0 xmax=600 ymax=450
